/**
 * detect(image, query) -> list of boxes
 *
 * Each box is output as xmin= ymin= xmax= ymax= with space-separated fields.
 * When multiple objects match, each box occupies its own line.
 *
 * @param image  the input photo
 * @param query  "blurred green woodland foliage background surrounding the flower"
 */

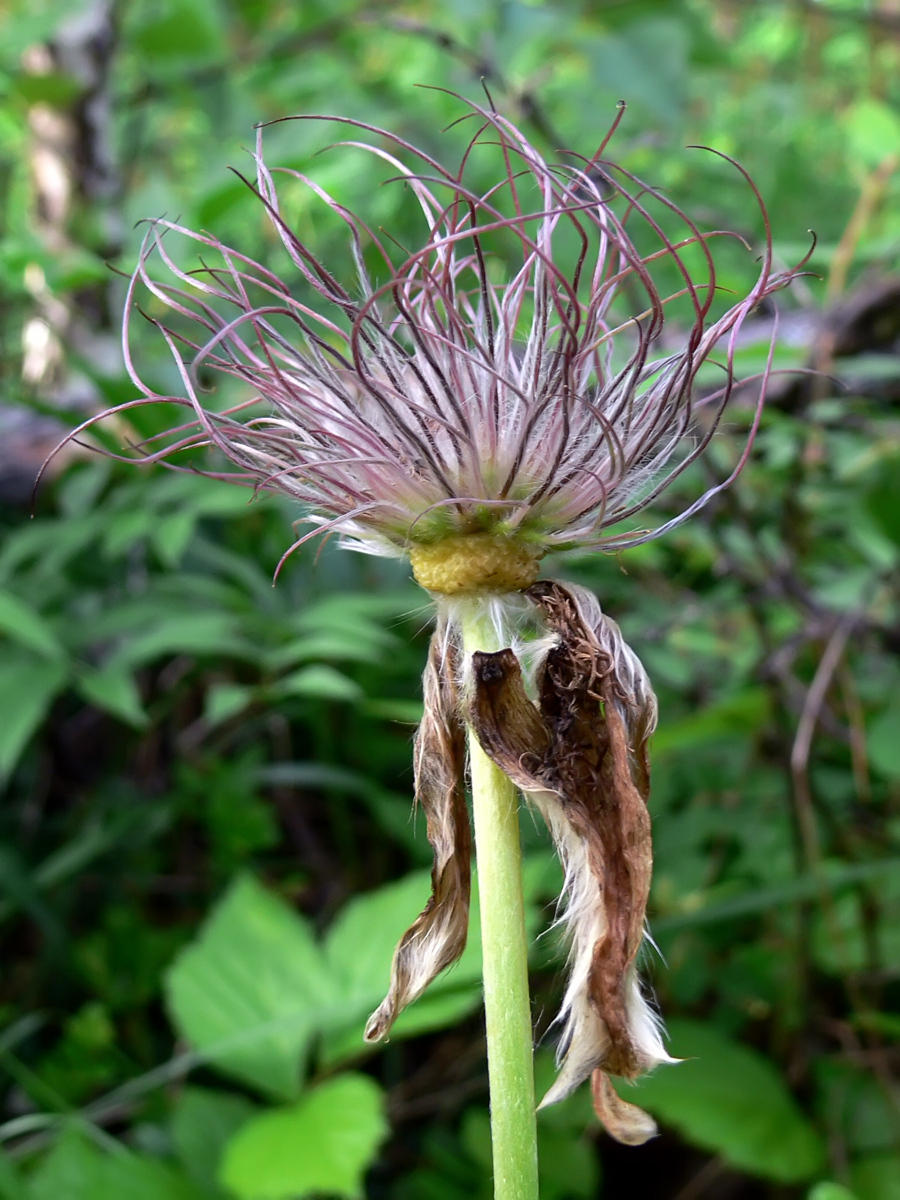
xmin=0 ymin=0 xmax=900 ymax=1200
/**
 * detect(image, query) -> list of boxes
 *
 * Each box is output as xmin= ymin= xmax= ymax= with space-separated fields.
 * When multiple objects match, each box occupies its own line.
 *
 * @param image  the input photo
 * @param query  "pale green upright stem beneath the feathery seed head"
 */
xmin=462 ymin=611 xmax=538 ymax=1200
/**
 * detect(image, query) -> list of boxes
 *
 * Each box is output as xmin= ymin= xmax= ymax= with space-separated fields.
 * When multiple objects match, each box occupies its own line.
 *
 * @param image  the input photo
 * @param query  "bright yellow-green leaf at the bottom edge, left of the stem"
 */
xmin=221 ymin=1074 xmax=388 ymax=1200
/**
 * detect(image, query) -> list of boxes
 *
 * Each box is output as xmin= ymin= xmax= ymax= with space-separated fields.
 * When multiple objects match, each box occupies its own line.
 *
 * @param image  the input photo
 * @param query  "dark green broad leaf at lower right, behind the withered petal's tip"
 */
xmin=622 ymin=1020 xmax=824 ymax=1183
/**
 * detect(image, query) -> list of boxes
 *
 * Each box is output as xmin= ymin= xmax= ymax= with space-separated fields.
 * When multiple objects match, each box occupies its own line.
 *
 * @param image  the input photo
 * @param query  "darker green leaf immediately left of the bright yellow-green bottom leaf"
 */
xmin=170 ymin=1087 xmax=259 ymax=1194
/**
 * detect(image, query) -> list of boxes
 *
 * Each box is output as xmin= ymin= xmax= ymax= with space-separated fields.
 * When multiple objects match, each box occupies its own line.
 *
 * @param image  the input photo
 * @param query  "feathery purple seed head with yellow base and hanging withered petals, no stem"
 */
xmin=47 ymin=104 xmax=811 ymax=1145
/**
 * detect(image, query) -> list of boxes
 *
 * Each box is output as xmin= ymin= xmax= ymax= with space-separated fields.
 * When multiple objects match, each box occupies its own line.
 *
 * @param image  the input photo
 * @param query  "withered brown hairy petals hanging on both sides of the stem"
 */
xmin=367 ymin=581 xmax=671 ymax=1145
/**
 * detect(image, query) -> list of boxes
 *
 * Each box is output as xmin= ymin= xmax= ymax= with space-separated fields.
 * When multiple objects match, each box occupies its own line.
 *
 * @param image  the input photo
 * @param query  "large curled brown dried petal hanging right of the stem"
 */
xmin=470 ymin=581 xmax=668 ymax=1142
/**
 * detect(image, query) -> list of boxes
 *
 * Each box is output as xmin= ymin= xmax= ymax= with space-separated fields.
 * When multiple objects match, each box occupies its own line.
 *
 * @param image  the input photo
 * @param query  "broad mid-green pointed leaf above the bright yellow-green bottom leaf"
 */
xmin=166 ymin=876 xmax=334 ymax=1098
